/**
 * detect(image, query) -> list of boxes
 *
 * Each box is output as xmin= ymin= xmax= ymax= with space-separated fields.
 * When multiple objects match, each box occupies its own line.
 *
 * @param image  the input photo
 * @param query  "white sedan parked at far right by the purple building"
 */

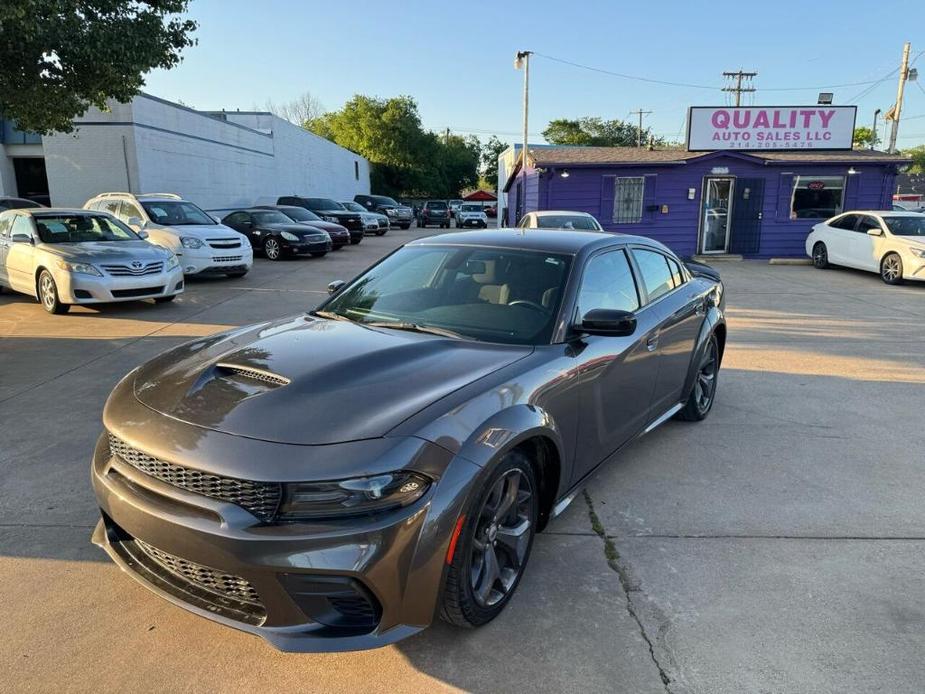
xmin=806 ymin=211 xmax=925 ymax=284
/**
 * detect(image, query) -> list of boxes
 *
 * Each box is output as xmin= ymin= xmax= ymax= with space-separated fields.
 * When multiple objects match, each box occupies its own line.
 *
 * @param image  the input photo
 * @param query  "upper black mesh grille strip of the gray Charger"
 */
xmin=109 ymin=434 xmax=282 ymax=521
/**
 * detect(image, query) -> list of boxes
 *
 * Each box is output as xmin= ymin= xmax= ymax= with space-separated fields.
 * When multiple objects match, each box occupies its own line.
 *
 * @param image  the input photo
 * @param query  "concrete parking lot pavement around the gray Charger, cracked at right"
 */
xmin=0 ymin=229 xmax=925 ymax=692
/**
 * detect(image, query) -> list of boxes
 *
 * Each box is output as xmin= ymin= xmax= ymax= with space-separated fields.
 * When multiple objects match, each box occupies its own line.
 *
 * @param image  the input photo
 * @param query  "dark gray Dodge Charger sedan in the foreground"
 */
xmin=92 ymin=229 xmax=726 ymax=651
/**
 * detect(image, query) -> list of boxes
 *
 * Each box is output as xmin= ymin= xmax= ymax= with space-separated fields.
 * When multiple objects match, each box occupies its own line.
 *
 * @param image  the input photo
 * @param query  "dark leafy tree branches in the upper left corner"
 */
xmin=0 ymin=0 xmax=196 ymax=134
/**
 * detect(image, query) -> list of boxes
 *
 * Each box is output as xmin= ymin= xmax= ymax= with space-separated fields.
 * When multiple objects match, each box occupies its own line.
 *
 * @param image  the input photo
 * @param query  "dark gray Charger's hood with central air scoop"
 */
xmin=134 ymin=316 xmax=533 ymax=445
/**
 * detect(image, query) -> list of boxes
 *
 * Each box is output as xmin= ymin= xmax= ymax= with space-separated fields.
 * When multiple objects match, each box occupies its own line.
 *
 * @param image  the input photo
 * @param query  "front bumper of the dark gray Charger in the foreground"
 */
xmin=91 ymin=384 xmax=480 ymax=652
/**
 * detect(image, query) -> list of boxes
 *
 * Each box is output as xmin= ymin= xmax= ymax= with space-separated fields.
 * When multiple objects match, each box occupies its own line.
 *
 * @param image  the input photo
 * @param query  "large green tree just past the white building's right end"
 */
xmin=305 ymin=94 xmax=480 ymax=197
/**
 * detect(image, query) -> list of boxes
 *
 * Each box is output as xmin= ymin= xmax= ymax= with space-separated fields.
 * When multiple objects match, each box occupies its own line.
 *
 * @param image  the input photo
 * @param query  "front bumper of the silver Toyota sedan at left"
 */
xmin=55 ymin=268 xmax=183 ymax=304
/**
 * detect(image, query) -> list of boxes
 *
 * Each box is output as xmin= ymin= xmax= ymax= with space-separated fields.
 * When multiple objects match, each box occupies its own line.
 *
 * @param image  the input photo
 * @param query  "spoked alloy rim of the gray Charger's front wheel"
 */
xmin=469 ymin=469 xmax=533 ymax=607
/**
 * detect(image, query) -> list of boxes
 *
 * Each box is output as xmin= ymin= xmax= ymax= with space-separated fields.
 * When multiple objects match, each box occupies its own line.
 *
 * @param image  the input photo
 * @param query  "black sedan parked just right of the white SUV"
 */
xmin=222 ymin=208 xmax=333 ymax=260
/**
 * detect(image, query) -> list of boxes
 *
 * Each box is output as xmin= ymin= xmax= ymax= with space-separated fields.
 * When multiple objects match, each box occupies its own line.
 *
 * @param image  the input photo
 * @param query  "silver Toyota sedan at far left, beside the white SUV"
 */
xmin=0 ymin=208 xmax=183 ymax=313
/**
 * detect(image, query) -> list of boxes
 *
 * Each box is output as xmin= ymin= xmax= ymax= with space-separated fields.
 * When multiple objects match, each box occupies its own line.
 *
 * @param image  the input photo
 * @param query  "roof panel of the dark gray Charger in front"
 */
xmin=408 ymin=228 xmax=652 ymax=254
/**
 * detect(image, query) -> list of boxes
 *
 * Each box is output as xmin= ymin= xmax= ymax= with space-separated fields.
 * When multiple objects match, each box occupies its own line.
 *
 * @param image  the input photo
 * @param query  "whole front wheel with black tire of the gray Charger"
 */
xmin=440 ymin=450 xmax=539 ymax=628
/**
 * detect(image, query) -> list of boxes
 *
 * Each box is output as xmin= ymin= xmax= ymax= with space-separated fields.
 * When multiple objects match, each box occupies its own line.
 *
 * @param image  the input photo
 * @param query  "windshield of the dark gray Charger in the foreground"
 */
xmin=320 ymin=246 xmax=571 ymax=345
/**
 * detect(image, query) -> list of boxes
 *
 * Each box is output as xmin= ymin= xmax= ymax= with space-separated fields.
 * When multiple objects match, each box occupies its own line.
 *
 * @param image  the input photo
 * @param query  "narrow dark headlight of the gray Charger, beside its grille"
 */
xmin=277 ymin=470 xmax=430 ymax=520
